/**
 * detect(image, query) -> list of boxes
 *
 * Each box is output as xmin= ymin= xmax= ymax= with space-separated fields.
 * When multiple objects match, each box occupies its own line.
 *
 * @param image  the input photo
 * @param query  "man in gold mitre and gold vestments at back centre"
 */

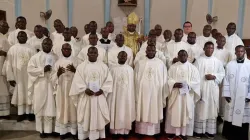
xmin=123 ymin=12 xmax=142 ymax=56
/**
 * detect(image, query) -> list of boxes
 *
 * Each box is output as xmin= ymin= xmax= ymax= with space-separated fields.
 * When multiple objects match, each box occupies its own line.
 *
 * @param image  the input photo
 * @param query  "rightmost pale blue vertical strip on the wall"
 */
xmin=237 ymin=0 xmax=246 ymax=38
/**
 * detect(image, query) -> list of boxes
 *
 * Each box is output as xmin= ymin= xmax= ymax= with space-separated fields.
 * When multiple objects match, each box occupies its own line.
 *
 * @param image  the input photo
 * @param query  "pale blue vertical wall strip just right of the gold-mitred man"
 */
xmin=144 ymin=0 xmax=151 ymax=35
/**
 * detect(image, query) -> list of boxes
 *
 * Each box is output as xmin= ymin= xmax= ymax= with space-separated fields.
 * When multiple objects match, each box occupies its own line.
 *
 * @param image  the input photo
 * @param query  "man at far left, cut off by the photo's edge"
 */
xmin=0 ymin=20 xmax=10 ymax=118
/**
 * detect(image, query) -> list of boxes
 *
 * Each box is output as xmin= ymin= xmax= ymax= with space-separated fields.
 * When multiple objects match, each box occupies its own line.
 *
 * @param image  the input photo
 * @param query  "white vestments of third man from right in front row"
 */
xmin=165 ymin=61 xmax=200 ymax=136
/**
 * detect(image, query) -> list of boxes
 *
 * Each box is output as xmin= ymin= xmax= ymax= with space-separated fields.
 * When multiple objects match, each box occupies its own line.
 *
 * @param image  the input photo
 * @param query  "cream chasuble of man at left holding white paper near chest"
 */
xmin=27 ymin=51 xmax=56 ymax=117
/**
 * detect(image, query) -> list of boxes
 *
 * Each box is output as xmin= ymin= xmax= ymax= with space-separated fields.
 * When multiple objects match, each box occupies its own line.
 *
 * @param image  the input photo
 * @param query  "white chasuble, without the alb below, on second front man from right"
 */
xmin=194 ymin=55 xmax=225 ymax=120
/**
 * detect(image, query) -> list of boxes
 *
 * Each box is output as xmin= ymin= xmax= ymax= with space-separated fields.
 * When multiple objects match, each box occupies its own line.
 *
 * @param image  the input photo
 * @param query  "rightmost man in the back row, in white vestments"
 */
xmin=225 ymin=22 xmax=244 ymax=58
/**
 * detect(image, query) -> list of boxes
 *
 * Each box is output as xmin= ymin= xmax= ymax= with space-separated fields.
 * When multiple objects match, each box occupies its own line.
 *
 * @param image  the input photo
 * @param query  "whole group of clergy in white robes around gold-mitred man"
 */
xmin=0 ymin=13 xmax=250 ymax=140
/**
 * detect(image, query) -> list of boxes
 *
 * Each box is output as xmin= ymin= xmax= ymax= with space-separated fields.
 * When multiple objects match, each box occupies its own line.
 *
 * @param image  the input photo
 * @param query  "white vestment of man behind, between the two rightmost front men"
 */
xmin=213 ymin=47 xmax=233 ymax=116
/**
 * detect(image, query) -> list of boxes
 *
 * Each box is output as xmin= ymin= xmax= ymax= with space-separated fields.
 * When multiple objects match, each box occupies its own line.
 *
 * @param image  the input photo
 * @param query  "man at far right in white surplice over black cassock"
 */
xmin=222 ymin=45 xmax=250 ymax=140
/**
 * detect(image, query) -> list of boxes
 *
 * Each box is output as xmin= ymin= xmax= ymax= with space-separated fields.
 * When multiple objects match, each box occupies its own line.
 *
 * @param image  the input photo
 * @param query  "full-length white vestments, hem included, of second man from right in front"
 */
xmin=194 ymin=55 xmax=225 ymax=135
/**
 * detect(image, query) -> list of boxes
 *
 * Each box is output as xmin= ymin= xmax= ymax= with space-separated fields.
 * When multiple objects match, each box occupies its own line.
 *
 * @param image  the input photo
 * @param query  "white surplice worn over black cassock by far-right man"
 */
xmin=222 ymin=59 xmax=250 ymax=127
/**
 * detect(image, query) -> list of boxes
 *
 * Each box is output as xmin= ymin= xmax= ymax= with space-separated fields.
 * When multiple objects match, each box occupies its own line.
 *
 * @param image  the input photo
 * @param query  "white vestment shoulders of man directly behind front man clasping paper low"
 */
xmin=77 ymin=45 xmax=106 ymax=62
